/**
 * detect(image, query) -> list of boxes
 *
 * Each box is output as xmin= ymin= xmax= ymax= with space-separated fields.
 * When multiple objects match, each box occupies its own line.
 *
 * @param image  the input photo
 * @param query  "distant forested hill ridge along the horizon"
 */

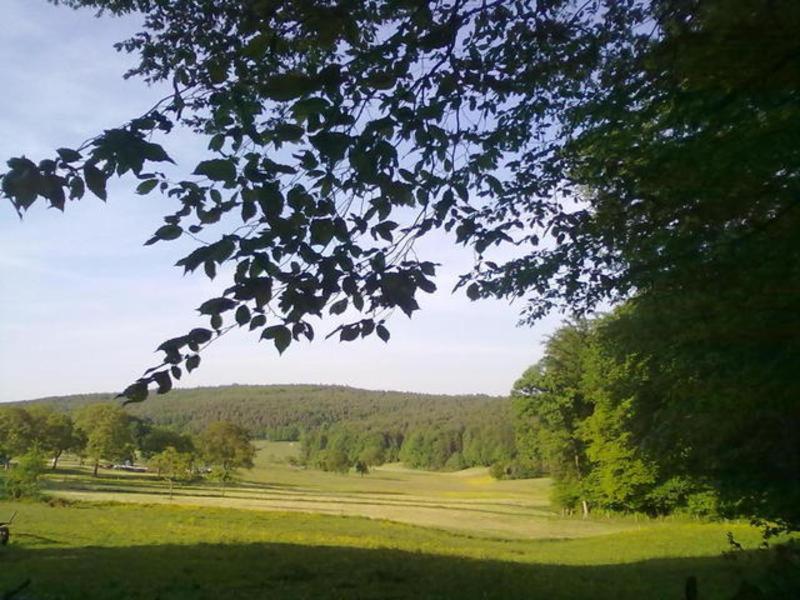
xmin=14 ymin=385 xmax=507 ymax=439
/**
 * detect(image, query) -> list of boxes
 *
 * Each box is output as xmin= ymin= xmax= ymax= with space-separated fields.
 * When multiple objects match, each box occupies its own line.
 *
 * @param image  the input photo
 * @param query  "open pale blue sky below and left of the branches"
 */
xmin=0 ymin=0 xmax=560 ymax=402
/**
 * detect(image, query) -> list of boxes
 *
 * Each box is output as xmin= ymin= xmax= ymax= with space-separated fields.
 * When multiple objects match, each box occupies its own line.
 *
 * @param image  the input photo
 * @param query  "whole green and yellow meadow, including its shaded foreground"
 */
xmin=0 ymin=444 xmax=780 ymax=599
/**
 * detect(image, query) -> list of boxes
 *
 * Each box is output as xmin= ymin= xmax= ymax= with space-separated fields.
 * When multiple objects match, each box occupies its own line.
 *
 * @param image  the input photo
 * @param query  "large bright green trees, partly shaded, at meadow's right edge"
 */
xmin=512 ymin=304 xmax=800 ymax=529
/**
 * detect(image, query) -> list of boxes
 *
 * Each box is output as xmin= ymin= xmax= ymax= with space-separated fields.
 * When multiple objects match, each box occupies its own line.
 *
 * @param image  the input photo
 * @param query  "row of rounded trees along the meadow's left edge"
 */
xmin=0 ymin=403 xmax=256 ymax=496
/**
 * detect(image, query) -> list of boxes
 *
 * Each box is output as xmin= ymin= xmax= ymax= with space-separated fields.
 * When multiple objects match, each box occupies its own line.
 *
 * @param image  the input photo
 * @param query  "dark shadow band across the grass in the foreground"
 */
xmin=0 ymin=543 xmax=776 ymax=600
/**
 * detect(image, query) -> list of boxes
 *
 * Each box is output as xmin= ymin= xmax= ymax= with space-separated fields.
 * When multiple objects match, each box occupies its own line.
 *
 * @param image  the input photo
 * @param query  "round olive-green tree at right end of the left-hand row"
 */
xmin=200 ymin=421 xmax=256 ymax=496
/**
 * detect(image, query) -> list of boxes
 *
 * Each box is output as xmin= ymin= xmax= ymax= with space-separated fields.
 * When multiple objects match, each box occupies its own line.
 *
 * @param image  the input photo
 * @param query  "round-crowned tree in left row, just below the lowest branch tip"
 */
xmin=75 ymin=403 xmax=134 ymax=477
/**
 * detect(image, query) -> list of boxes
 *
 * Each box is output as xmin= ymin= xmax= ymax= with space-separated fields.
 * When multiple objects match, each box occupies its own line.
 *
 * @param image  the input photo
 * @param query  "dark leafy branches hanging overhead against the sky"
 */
xmin=2 ymin=0 xmax=798 ymax=401
